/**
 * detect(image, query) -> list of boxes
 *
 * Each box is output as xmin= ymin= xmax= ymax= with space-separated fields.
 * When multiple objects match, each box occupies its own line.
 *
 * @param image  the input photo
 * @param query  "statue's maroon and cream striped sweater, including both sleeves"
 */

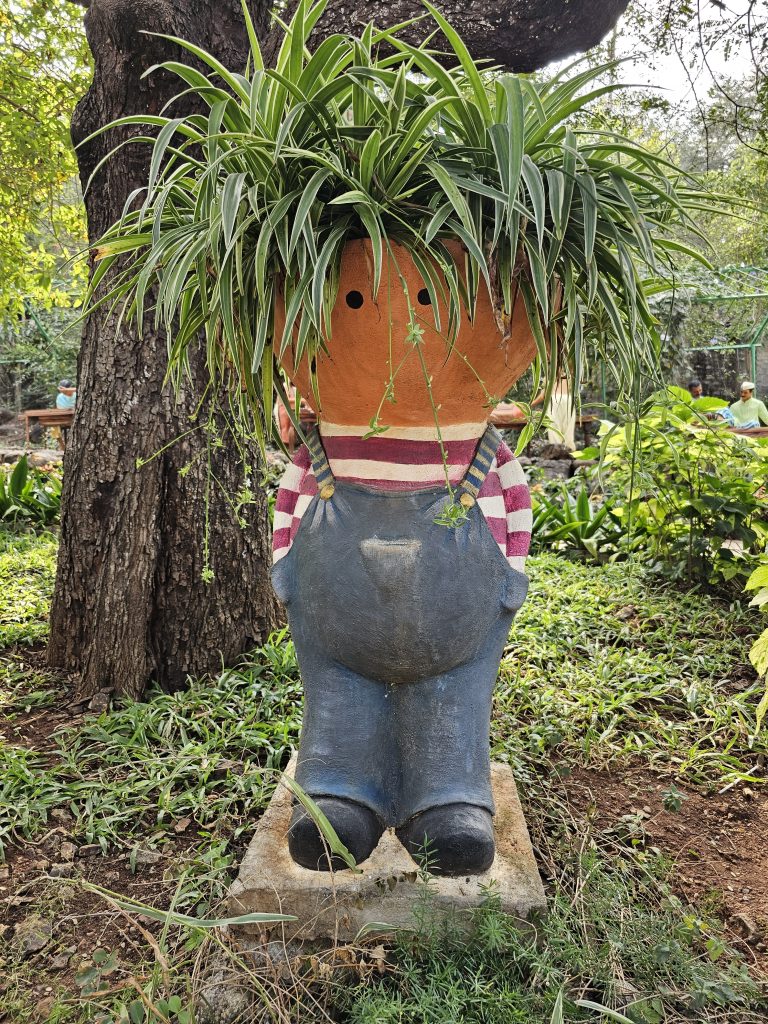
xmin=272 ymin=423 xmax=531 ymax=572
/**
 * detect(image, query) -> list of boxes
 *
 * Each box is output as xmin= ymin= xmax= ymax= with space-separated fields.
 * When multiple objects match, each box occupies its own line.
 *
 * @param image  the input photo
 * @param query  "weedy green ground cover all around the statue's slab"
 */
xmin=0 ymin=536 xmax=768 ymax=1024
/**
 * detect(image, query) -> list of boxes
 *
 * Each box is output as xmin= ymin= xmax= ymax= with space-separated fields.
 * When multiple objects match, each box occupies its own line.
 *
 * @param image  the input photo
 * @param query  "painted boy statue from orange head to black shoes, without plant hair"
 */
xmin=272 ymin=243 xmax=536 ymax=874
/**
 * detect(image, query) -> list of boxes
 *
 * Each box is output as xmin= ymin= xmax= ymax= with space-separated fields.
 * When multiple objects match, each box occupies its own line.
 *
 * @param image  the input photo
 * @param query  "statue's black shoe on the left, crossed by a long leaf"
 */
xmin=288 ymin=797 xmax=384 ymax=871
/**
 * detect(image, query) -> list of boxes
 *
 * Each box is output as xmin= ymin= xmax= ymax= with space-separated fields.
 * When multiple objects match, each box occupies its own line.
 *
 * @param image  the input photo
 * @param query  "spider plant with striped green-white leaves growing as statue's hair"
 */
xmin=87 ymin=0 xmax=729 ymax=443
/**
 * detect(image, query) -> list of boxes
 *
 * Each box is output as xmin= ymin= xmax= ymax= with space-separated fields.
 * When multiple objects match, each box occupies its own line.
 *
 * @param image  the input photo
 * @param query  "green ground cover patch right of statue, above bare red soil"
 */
xmin=494 ymin=555 xmax=768 ymax=783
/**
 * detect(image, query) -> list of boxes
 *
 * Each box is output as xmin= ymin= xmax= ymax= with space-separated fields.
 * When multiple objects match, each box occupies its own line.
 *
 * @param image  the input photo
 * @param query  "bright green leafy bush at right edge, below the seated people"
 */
xmin=582 ymin=387 xmax=768 ymax=728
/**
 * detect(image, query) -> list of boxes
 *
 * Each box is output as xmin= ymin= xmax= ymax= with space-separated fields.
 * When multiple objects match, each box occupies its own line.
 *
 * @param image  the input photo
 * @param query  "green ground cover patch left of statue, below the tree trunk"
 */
xmin=0 ymin=634 xmax=301 ymax=872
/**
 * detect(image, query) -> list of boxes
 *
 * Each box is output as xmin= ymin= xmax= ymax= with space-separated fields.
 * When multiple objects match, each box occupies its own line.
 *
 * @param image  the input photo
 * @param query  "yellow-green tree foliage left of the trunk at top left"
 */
xmin=0 ymin=0 xmax=91 ymax=318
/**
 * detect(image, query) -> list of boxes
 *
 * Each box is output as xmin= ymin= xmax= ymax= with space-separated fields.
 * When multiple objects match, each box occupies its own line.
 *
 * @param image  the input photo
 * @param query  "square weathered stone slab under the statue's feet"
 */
xmin=227 ymin=759 xmax=546 ymax=942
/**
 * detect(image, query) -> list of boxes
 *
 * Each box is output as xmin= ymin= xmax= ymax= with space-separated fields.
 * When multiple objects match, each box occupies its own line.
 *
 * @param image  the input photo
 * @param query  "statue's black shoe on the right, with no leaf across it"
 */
xmin=396 ymin=804 xmax=496 ymax=876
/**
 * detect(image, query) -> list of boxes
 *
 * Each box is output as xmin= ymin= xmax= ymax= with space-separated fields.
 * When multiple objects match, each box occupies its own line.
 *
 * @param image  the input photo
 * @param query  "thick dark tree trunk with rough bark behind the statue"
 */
xmin=50 ymin=0 xmax=278 ymax=696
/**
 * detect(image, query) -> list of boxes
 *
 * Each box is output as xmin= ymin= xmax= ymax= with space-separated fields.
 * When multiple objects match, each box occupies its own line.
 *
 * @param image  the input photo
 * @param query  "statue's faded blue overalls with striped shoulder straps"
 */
xmin=272 ymin=427 xmax=527 ymax=866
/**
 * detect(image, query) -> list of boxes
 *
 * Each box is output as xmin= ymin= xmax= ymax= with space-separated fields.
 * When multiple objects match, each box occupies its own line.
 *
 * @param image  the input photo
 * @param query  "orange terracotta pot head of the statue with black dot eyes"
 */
xmin=274 ymin=240 xmax=537 ymax=427
